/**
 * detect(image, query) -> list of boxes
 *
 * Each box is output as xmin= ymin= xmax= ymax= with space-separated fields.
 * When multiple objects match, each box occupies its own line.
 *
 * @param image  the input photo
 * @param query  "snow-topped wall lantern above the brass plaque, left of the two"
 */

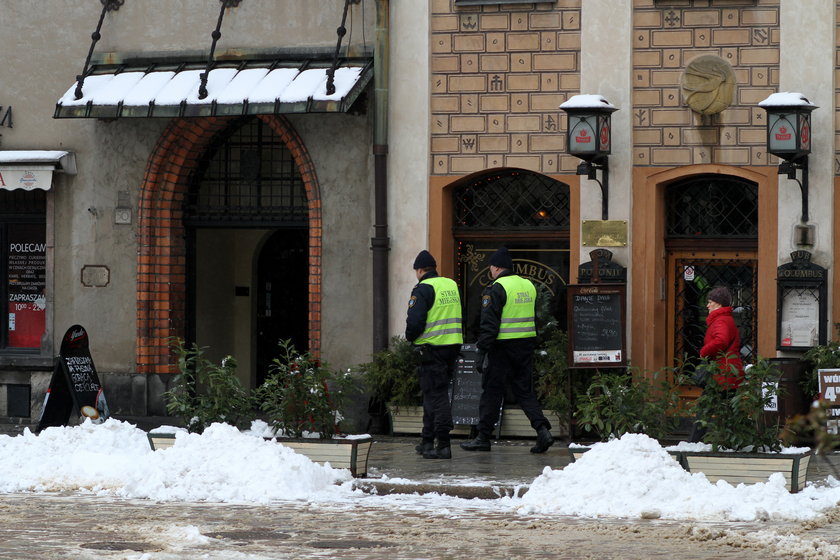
xmin=560 ymin=94 xmax=618 ymax=220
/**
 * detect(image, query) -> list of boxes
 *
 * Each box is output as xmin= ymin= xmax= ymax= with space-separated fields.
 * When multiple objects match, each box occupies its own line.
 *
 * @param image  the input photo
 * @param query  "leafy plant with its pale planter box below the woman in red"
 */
xmin=682 ymin=358 xmax=811 ymax=492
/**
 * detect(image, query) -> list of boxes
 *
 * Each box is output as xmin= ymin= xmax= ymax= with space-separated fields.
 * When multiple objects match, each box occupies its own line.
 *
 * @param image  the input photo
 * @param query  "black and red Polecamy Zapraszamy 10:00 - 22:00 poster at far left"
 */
xmin=6 ymin=224 xmax=47 ymax=348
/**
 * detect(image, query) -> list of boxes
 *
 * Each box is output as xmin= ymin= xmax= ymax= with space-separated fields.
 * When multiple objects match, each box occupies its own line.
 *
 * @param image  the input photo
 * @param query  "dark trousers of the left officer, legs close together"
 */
xmin=417 ymin=344 xmax=461 ymax=442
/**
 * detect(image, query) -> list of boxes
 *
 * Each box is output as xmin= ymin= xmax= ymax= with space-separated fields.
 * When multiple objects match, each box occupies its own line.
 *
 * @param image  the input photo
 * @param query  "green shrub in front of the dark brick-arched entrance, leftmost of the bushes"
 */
xmin=164 ymin=338 xmax=253 ymax=433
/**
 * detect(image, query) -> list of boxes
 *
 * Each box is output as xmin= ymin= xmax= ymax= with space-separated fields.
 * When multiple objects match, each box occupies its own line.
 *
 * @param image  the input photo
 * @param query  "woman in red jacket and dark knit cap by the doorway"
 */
xmin=689 ymin=286 xmax=744 ymax=442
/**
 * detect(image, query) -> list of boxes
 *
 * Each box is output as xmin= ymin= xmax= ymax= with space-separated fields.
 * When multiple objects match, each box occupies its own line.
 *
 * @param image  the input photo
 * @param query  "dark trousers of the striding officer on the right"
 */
xmin=478 ymin=338 xmax=551 ymax=437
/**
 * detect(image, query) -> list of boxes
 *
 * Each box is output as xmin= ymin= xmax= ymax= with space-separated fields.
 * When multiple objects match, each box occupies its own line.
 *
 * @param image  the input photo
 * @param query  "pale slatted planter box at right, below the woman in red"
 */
xmin=682 ymin=450 xmax=811 ymax=492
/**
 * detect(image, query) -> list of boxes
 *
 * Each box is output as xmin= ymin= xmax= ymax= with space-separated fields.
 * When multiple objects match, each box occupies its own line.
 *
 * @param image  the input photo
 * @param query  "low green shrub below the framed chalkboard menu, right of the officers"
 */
xmin=575 ymin=370 xmax=681 ymax=441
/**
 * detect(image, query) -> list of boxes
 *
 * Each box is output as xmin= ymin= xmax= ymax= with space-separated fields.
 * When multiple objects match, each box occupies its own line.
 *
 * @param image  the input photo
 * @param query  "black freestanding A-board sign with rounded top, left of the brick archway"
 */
xmin=37 ymin=325 xmax=110 ymax=431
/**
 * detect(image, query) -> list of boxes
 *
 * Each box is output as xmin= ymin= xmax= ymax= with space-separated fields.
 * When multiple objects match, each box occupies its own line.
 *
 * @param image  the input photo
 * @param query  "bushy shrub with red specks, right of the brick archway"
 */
xmin=254 ymin=339 xmax=349 ymax=439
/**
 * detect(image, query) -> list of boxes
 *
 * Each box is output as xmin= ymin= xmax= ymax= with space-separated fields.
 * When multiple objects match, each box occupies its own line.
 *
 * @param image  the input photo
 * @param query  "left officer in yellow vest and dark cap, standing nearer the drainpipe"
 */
xmin=405 ymin=251 xmax=464 ymax=459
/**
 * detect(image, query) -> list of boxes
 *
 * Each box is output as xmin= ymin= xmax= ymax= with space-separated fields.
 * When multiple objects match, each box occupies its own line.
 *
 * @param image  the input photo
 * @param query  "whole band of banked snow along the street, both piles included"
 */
xmin=0 ymin=419 xmax=840 ymax=521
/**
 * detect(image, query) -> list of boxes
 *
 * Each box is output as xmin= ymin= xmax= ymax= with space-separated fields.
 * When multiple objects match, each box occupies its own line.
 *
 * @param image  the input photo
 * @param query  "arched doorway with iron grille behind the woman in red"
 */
xmin=665 ymin=174 xmax=759 ymax=363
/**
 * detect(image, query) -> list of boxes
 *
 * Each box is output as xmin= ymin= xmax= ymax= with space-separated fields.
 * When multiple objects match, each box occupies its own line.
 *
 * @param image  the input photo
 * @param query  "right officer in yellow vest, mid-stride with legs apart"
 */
xmin=461 ymin=247 xmax=554 ymax=453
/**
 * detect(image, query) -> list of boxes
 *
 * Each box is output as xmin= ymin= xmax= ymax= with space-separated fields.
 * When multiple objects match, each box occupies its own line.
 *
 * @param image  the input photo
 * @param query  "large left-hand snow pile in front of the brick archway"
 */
xmin=0 ymin=419 xmax=352 ymax=503
